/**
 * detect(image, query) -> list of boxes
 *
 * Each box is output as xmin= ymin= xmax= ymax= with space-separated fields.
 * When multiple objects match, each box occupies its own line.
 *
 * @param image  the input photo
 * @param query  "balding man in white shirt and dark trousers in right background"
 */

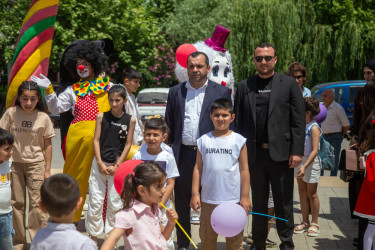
xmin=321 ymin=89 xmax=350 ymax=176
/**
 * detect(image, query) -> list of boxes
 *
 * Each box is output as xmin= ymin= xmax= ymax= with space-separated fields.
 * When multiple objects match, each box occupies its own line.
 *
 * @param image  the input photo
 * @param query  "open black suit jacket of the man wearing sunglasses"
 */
xmin=234 ymin=72 xmax=305 ymax=165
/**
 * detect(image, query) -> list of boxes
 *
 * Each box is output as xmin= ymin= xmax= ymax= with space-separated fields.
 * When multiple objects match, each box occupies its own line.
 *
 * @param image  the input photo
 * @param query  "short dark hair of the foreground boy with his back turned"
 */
xmin=40 ymin=174 xmax=81 ymax=217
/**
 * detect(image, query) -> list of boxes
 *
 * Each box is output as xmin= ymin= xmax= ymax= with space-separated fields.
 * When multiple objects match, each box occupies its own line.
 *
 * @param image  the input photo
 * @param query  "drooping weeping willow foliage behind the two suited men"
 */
xmin=166 ymin=0 xmax=375 ymax=87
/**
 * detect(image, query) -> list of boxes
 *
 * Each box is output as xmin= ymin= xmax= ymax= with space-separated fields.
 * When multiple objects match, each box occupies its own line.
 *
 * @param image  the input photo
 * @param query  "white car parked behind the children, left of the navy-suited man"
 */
xmin=136 ymin=88 xmax=169 ymax=121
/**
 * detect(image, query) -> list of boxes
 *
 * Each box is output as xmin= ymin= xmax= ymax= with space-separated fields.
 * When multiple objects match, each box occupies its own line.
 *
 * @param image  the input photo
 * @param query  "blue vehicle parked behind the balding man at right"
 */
xmin=311 ymin=80 xmax=366 ymax=124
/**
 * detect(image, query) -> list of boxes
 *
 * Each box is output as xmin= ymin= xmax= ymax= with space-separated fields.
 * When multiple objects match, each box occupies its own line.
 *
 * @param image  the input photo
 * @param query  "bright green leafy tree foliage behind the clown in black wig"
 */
xmin=0 ymin=0 xmax=172 ymax=88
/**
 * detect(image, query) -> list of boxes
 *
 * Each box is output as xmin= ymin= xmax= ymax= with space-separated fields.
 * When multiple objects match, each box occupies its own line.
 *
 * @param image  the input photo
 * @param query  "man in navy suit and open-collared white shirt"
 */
xmin=165 ymin=52 xmax=231 ymax=249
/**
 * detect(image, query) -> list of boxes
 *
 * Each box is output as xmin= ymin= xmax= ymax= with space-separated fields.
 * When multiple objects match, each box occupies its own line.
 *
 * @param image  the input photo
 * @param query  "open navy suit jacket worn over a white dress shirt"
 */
xmin=165 ymin=80 xmax=231 ymax=162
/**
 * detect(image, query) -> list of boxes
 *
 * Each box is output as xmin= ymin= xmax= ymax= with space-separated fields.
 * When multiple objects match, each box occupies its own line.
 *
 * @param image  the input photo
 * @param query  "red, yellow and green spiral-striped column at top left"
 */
xmin=6 ymin=0 xmax=59 ymax=108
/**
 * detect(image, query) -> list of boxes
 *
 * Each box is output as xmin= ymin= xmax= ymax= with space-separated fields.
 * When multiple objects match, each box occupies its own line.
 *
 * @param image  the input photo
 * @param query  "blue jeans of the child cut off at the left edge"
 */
xmin=0 ymin=212 xmax=14 ymax=250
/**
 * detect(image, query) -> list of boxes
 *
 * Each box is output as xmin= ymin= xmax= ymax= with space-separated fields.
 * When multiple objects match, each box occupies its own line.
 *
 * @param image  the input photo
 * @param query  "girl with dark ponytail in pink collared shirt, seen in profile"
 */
xmin=101 ymin=162 xmax=178 ymax=250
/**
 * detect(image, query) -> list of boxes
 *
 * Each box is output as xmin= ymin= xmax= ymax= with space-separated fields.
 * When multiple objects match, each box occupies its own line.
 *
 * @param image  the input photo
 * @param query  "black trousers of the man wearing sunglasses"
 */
xmin=249 ymin=147 xmax=294 ymax=249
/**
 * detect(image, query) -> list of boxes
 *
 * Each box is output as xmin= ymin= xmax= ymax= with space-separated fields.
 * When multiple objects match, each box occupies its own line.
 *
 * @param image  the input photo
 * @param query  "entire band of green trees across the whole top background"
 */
xmin=0 ymin=0 xmax=375 ymax=90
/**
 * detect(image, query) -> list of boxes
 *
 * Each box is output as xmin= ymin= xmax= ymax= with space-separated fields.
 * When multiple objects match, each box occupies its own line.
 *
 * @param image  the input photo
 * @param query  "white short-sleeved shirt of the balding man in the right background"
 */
xmin=321 ymin=101 xmax=350 ymax=134
